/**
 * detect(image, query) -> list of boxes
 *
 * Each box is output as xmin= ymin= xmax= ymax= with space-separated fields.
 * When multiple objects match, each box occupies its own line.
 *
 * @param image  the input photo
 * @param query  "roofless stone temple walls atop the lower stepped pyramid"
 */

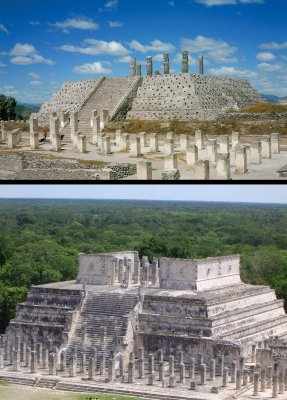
xmin=77 ymin=251 xmax=241 ymax=290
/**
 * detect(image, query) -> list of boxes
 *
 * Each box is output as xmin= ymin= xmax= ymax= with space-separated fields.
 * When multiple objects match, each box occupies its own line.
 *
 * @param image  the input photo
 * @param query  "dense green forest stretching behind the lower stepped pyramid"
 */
xmin=0 ymin=200 xmax=287 ymax=332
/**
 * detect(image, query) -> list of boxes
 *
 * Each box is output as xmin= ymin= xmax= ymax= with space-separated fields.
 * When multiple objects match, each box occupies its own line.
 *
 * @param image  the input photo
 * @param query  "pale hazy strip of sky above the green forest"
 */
xmin=0 ymin=184 xmax=287 ymax=204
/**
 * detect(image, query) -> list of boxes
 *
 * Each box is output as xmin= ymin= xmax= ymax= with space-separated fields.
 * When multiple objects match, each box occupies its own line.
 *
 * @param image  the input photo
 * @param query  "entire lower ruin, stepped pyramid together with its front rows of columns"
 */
xmin=0 ymin=251 xmax=287 ymax=400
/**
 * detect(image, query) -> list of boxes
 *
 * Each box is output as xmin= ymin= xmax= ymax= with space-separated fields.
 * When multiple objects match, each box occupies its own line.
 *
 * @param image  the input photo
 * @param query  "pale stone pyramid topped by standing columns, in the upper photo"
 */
xmin=38 ymin=51 xmax=261 ymax=126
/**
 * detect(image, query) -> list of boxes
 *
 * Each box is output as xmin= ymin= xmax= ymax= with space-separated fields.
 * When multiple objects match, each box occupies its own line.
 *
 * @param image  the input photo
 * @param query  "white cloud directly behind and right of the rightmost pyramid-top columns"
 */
xmin=181 ymin=35 xmax=238 ymax=63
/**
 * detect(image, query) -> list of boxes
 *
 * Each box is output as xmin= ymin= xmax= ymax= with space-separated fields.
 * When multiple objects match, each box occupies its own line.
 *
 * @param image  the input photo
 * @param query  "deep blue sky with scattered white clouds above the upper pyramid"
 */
xmin=0 ymin=0 xmax=287 ymax=103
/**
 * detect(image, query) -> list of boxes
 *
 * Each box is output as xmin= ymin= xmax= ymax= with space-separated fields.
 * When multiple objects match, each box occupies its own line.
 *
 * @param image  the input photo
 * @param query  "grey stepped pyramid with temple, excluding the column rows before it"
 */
xmin=5 ymin=252 xmax=287 ymax=363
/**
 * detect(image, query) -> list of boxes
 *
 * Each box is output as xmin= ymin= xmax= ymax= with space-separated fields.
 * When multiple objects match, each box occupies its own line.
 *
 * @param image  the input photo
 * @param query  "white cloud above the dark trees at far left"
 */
xmin=8 ymin=43 xmax=55 ymax=65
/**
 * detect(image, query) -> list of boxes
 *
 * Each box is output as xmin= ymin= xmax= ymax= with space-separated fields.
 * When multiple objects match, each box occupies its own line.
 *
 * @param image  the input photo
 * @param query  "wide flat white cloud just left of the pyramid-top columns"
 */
xmin=58 ymin=39 xmax=129 ymax=56
